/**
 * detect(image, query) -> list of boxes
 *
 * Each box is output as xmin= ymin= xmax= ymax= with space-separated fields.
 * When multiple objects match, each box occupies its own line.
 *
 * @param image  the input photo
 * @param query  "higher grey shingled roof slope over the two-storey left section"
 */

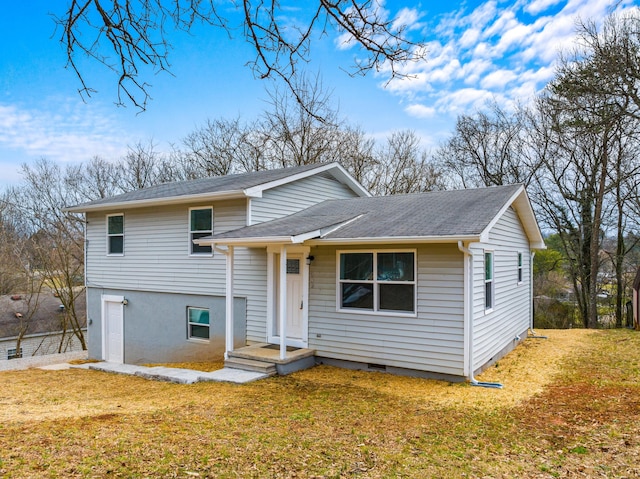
xmin=70 ymin=164 xmax=330 ymax=210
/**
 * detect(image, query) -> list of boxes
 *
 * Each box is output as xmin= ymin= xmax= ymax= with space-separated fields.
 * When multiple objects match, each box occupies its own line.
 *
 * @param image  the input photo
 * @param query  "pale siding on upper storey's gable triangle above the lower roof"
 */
xmin=251 ymin=175 xmax=356 ymax=224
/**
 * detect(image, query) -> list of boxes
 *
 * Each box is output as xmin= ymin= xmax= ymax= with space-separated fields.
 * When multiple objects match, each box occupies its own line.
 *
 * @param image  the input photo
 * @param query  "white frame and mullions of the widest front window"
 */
xmin=336 ymin=248 xmax=418 ymax=318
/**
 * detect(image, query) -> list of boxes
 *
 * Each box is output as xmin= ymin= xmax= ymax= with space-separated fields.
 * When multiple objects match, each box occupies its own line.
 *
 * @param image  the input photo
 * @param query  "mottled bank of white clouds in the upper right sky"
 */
xmin=382 ymin=0 xmax=636 ymax=124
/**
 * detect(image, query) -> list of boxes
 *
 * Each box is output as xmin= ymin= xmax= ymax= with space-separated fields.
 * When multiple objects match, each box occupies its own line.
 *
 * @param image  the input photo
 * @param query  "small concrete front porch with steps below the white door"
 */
xmin=224 ymin=343 xmax=315 ymax=376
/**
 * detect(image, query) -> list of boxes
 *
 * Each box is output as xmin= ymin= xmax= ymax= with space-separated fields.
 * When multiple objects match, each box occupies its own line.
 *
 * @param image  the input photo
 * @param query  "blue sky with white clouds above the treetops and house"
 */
xmin=0 ymin=0 xmax=638 ymax=187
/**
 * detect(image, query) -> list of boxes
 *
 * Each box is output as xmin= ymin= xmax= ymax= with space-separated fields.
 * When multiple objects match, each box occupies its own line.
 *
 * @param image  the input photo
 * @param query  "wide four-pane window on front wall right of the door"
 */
xmin=338 ymin=250 xmax=416 ymax=314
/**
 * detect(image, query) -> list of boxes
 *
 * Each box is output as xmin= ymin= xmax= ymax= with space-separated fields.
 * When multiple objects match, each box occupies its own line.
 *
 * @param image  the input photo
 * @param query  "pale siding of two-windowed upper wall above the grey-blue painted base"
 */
xmin=87 ymin=200 xmax=245 ymax=294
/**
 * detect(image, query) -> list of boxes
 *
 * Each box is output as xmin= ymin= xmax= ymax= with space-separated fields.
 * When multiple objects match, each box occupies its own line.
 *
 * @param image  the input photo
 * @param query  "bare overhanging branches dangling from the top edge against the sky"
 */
xmin=54 ymin=0 xmax=425 ymax=110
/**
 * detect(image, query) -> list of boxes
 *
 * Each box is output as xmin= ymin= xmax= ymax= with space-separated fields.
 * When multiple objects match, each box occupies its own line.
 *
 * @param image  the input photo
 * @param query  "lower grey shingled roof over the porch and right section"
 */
xmin=210 ymin=185 xmax=521 ymax=240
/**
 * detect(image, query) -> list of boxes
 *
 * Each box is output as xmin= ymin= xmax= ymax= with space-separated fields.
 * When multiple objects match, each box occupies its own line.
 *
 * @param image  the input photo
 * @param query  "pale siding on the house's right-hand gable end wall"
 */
xmin=473 ymin=208 xmax=531 ymax=370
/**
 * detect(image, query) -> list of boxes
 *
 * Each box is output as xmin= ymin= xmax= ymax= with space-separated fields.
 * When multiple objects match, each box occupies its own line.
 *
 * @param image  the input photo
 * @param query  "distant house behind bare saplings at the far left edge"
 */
xmin=0 ymin=292 xmax=86 ymax=360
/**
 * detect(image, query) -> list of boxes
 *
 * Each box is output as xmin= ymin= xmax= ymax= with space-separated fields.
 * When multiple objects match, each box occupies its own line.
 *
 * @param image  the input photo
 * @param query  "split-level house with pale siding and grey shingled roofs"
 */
xmin=68 ymin=163 xmax=544 ymax=381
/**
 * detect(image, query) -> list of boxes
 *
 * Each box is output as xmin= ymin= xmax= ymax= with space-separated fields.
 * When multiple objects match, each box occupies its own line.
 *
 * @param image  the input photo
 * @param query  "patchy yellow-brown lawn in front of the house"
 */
xmin=0 ymin=330 xmax=640 ymax=478
